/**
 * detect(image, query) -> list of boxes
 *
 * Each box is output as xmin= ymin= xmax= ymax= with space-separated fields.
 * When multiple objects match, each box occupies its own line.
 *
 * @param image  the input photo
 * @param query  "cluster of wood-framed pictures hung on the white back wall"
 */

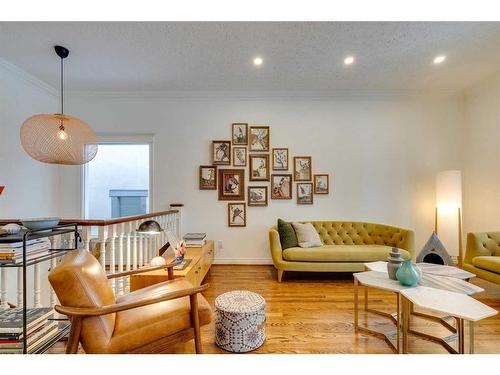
xmin=199 ymin=123 xmax=330 ymax=228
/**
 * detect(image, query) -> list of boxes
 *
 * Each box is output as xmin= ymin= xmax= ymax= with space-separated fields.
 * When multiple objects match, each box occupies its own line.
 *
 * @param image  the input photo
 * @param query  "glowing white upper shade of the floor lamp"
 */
xmin=436 ymin=171 xmax=462 ymax=209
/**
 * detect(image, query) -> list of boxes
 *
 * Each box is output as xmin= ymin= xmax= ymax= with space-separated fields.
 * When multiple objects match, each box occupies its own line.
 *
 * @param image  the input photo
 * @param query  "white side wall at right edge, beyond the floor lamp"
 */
xmin=463 ymin=75 xmax=500 ymax=232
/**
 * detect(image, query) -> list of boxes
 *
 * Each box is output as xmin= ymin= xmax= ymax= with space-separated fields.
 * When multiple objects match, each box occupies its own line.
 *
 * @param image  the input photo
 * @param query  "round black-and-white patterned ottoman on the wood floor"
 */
xmin=215 ymin=290 xmax=266 ymax=353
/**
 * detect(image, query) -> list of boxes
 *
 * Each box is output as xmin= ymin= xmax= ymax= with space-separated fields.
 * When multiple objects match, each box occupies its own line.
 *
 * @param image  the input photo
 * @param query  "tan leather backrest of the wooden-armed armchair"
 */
xmin=49 ymin=250 xmax=116 ymax=349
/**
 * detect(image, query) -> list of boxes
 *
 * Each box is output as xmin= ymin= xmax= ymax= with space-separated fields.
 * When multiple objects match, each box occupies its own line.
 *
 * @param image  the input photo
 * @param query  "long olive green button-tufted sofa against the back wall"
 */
xmin=269 ymin=221 xmax=415 ymax=282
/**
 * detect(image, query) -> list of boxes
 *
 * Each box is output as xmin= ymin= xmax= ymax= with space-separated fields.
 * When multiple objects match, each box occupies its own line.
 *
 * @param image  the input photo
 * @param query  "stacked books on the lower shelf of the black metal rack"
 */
xmin=0 ymin=307 xmax=59 ymax=354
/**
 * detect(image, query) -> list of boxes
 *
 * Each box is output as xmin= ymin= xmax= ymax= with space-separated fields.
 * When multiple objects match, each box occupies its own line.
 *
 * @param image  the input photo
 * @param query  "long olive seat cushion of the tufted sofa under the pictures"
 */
xmin=283 ymin=245 xmax=411 ymax=262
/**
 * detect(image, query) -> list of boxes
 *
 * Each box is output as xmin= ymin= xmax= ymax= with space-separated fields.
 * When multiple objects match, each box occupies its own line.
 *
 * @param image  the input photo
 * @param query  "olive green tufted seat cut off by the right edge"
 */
xmin=463 ymin=232 xmax=500 ymax=284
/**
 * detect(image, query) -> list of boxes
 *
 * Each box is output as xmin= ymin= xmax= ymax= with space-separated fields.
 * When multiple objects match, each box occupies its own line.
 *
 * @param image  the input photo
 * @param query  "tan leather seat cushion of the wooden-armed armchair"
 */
xmin=102 ymin=279 xmax=212 ymax=353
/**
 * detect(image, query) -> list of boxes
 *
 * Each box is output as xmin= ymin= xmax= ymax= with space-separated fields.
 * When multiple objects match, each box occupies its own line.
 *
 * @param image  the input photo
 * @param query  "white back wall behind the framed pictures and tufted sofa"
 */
xmin=61 ymin=94 xmax=463 ymax=263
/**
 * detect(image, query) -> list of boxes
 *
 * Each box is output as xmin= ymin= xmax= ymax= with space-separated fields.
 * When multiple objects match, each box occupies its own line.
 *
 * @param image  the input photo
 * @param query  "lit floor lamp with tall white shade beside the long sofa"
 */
xmin=434 ymin=170 xmax=463 ymax=267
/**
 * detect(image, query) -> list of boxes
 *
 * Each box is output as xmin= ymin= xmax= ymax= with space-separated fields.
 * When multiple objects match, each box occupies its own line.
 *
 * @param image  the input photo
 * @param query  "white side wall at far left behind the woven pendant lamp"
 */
xmin=0 ymin=59 xmax=59 ymax=218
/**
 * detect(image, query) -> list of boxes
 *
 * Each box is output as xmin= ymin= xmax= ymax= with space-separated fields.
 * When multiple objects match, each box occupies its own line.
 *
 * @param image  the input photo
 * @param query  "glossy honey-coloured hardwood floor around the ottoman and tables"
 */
xmin=47 ymin=265 xmax=500 ymax=354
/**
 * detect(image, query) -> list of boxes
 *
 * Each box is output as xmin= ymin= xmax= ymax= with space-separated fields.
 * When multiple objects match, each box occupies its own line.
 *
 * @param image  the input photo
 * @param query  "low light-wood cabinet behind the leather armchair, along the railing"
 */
xmin=130 ymin=240 xmax=214 ymax=291
